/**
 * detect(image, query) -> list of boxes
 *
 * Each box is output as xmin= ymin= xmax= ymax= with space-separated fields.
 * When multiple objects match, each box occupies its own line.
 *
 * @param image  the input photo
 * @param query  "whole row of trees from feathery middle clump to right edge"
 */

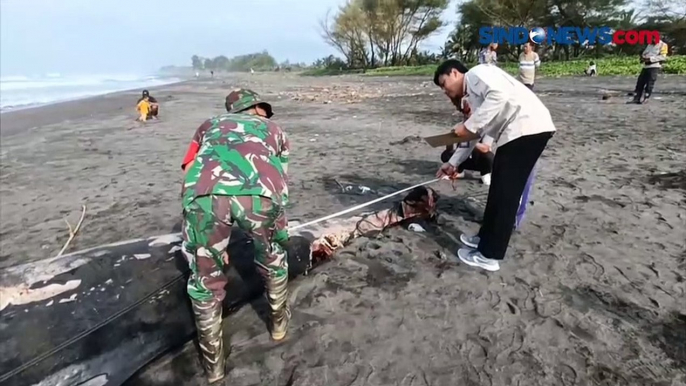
xmin=314 ymin=0 xmax=686 ymax=68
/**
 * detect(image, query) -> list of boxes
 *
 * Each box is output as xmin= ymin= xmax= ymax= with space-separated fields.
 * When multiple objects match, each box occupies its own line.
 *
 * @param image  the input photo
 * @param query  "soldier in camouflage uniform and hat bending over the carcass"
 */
xmin=182 ymin=89 xmax=290 ymax=383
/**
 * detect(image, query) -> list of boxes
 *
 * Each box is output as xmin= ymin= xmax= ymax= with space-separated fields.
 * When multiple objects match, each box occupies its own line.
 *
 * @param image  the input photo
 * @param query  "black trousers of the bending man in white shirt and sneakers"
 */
xmin=478 ymin=133 xmax=553 ymax=260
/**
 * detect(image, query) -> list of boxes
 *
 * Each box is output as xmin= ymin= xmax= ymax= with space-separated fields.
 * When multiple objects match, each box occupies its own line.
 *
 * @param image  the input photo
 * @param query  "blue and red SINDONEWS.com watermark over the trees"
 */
xmin=479 ymin=26 xmax=660 ymax=46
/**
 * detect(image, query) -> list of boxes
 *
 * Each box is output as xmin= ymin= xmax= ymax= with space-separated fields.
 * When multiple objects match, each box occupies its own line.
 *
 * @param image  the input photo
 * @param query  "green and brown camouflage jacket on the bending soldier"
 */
xmin=182 ymin=114 xmax=289 ymax=208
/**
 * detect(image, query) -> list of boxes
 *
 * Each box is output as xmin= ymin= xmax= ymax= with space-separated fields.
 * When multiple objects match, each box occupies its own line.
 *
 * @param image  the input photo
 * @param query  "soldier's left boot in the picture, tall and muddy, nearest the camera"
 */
xmin=191 ymin=299 xmax=226 ymax=383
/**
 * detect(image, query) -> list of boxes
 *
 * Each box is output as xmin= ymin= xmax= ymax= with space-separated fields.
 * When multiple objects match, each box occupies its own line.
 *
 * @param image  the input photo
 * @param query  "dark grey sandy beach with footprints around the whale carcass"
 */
xmin=0 ymin=73 xmax=686 ymax=386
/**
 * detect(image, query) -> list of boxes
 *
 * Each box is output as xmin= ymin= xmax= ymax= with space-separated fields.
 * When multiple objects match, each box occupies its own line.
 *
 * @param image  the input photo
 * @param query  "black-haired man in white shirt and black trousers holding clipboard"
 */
xmin=434 ymin=60 xmax=555 ymax=271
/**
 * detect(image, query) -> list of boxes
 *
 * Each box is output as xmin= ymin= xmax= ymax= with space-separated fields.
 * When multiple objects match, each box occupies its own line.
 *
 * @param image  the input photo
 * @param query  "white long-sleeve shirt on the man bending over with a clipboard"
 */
xmin=464 ymin=65 xmax=556 ymax=152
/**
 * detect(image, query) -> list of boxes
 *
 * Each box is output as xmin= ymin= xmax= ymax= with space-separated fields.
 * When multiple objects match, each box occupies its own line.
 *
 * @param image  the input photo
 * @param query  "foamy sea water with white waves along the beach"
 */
xmin=0 ymin=74 xmax=181 ymax=112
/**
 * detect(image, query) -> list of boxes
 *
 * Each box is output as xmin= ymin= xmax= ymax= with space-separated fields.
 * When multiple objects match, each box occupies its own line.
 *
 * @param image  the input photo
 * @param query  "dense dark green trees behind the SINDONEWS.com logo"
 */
xmin=443 ymin=0 xmax=686 ymax=61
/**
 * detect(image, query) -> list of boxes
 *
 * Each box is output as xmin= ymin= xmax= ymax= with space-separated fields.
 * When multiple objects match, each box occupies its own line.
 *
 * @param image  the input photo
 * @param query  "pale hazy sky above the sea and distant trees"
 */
xmin=0 ymin=0 xmax=455 ymax=76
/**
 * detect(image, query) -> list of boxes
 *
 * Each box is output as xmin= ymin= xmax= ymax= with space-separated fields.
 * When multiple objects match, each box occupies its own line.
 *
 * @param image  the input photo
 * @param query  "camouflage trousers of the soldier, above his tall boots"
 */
xmin=182 ymin=196 xmax=288 ymax=302
